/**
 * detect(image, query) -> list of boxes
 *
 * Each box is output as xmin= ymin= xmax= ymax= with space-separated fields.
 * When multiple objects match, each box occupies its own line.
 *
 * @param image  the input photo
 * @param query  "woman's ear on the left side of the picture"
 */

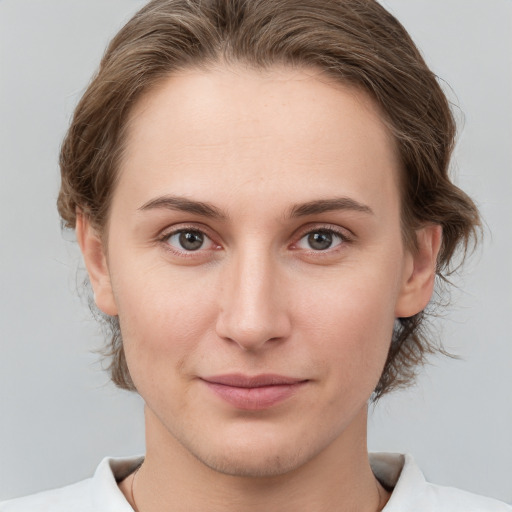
xmin=75 ymin=213 xmax=117 ymax=316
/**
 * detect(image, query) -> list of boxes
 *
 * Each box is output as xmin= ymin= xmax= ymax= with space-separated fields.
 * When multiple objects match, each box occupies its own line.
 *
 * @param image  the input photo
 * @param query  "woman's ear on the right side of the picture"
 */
xmin=395 ymin=224 xmax=442 ymax=318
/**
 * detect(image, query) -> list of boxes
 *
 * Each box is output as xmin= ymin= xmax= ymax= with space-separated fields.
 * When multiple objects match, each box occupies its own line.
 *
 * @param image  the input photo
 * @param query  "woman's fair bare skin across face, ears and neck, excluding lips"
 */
xmin=77 ymin=66 xmax=441 ymax=512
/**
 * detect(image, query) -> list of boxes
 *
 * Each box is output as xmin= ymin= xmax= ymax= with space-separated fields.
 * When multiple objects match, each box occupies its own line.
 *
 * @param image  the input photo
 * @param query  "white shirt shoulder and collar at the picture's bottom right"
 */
xmin=370 ymin=453 xmax=512 ymax=512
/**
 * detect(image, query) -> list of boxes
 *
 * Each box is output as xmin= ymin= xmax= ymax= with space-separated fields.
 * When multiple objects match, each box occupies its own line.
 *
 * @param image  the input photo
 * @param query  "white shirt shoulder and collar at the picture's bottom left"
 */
xmin=0 ymin=457 xmax=142 ymax=512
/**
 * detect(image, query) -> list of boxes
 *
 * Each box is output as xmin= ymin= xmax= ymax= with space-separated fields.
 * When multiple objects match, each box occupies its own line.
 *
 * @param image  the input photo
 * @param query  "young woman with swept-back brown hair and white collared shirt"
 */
xmin=0 ymin=0 xmax=511 ymax=512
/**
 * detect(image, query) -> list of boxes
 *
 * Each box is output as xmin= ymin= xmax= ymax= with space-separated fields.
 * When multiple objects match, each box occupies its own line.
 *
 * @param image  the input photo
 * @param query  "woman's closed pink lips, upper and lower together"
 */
xmin=201 ymin=374 xmax=308 ymax=411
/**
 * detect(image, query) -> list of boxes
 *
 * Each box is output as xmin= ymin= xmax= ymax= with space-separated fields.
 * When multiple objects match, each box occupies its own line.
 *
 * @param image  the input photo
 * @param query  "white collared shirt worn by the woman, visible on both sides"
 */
xmin=0 ymin=453 xmax=512 ymax=512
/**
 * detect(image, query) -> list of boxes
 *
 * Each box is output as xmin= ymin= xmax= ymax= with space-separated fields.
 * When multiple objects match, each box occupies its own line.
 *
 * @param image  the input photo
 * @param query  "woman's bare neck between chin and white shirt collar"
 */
xmin=121 ymin=409 xmax=389 ymax=512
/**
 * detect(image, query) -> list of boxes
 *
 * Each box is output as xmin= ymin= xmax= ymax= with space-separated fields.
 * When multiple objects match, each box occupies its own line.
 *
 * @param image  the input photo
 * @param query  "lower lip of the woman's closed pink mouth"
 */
xmin=203 ymin=381 xmax=306 ymax=411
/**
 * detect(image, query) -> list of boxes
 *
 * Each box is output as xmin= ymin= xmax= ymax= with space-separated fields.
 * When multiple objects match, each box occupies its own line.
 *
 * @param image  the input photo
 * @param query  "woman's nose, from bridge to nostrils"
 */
xmin=216 ymin=248 xmax=291 ymax=351
